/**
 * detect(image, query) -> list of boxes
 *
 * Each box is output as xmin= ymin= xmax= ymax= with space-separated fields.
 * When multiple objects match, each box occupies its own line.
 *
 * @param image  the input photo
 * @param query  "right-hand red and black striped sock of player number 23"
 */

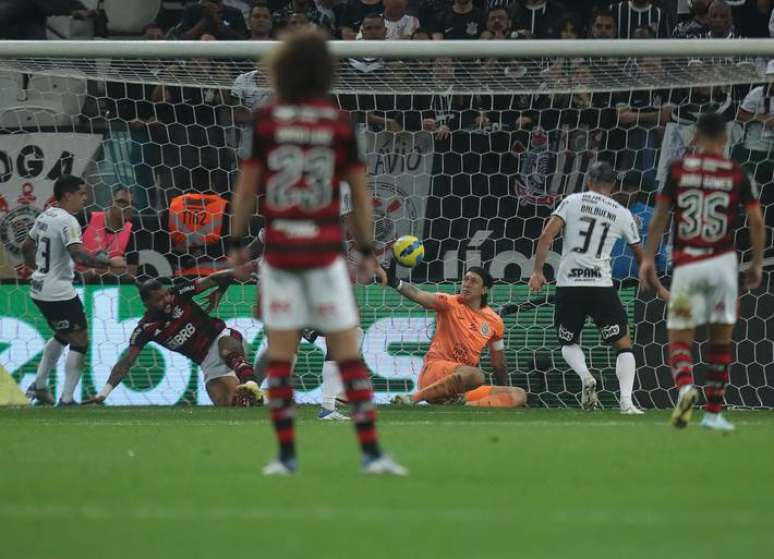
xmin=338 ymin=359 xmax=382 ymax=457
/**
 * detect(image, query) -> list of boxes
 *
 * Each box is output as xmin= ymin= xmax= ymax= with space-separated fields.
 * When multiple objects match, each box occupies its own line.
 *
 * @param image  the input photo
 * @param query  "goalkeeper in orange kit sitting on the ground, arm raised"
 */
xmin=387 ymin=264 xmax=527 ymax=408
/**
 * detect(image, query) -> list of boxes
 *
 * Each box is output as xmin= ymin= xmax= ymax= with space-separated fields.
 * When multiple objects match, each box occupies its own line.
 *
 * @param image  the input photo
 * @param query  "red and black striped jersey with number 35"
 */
xmin=658 ymin=154 xmax=760 ymax=266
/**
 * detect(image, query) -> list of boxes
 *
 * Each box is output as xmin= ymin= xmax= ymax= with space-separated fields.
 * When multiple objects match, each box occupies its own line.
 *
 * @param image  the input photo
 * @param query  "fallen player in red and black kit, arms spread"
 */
xmin=85 ymin=262 xmax=262 ymax=406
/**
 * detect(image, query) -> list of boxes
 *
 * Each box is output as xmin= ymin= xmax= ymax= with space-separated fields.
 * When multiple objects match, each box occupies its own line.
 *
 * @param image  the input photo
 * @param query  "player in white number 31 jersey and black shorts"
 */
xmin=529 ymin=161 xmax=669 ymax=415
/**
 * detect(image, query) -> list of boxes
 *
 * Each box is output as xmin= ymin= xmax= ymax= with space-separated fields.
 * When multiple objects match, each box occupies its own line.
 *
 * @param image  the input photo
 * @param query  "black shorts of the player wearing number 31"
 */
xmin=554 ymin=287 xmax=627 ymax=345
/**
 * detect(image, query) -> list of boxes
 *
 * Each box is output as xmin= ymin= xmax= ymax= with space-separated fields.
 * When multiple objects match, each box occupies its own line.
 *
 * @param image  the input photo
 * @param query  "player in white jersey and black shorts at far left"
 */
xmin=21 ymin=175 xmax=126 ymax=406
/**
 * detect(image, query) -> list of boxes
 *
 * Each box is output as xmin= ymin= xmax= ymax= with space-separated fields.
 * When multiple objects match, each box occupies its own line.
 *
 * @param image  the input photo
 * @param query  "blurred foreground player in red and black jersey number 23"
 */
xmin=231 ymin=30 xmax=406 ymax=475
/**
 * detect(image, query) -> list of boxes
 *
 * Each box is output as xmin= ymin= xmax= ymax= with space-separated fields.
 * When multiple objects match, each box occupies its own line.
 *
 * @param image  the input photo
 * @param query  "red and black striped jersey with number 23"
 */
xmin=243 ymin=99 xmax=365 ymax=269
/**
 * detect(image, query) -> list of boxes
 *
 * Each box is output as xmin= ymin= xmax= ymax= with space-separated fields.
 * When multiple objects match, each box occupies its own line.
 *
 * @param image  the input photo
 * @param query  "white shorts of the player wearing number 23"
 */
xmin=260 ymin=256 xmax=360 ymax=334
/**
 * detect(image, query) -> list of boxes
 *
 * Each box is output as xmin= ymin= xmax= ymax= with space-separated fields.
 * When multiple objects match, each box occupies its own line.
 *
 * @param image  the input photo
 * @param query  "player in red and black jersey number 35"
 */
xmin=640 ymin=113 xmax=766 ymax=431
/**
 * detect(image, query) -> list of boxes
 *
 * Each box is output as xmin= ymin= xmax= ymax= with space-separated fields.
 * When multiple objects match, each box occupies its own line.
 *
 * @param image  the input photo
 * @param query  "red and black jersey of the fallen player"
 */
xmin=129 ymin=282 xmax=226 ymax=365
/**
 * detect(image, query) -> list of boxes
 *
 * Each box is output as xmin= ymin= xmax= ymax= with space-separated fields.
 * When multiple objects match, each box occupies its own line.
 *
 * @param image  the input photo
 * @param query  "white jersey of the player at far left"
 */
xmin=29 ymin=207 xmax=81 ymax=301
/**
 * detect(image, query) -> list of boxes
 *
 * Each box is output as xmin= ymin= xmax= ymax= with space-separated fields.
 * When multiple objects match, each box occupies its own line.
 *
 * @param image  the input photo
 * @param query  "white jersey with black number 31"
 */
xmin=553 ymin=192 xmax=640 ymax=287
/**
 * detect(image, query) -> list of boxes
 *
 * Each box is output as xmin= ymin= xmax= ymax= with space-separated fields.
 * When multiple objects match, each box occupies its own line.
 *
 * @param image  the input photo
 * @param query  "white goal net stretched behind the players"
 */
xmin=0 ymin=40 xmax=774 ymax=407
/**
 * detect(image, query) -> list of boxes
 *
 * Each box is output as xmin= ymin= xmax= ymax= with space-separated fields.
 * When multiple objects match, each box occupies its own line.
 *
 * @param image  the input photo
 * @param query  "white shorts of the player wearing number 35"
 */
xmin=667 ymin=252 xmax=739 ymax=330
